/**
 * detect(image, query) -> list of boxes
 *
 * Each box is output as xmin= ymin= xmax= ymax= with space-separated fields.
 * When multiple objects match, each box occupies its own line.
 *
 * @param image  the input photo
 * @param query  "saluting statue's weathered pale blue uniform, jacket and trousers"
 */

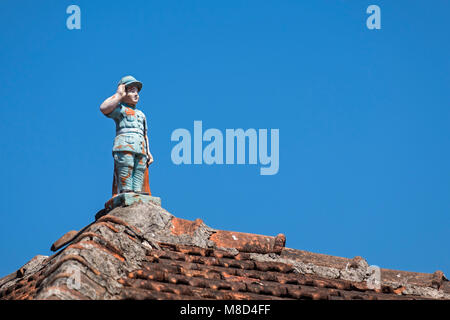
xmin=106 ymin=103 xmax=147 ymax=191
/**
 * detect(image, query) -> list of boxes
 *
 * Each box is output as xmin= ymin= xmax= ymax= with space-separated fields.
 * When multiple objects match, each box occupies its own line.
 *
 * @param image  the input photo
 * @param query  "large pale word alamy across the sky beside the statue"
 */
xmin=170 ymin=121 xmax=280 ymax=175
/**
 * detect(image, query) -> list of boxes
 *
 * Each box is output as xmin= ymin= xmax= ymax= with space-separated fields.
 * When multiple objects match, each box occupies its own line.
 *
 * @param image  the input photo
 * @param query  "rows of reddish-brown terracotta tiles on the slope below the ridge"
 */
xmin=112 ymin=239 xmax=436 ymax=299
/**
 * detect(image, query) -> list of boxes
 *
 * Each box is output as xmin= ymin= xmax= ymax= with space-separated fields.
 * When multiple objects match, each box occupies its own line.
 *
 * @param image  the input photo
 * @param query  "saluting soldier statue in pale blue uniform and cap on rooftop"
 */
xmin=100 ymin=76 xmax=153 ymax=196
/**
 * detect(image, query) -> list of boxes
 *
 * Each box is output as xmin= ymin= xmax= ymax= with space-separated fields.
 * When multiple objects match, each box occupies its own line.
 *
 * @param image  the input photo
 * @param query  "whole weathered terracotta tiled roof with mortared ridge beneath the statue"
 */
xmin=0 ymin=203 xmax=450 ymax=300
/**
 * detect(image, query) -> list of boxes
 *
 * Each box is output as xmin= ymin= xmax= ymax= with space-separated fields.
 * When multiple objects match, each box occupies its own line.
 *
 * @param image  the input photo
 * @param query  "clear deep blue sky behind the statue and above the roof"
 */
xmin=0 ymin=0 xmax=450 ymax=276
